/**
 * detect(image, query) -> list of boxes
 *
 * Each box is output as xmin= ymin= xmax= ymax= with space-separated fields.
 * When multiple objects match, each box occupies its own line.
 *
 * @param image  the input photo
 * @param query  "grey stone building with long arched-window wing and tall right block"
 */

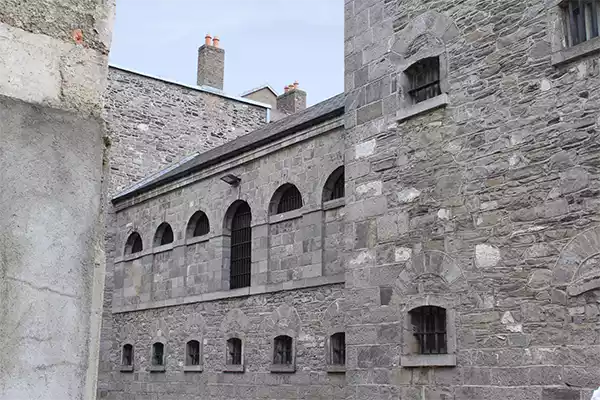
xmin=99 ymin=0 xmax=600 ymax=400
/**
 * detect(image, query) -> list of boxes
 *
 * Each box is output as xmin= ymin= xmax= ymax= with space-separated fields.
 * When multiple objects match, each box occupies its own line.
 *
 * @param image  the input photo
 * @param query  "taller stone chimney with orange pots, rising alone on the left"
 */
xmin=198 ymin=35 xmax=225 ymax=90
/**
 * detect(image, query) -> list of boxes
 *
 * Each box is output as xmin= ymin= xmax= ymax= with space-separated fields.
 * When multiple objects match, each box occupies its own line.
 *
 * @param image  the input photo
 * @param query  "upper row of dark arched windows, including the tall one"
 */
xmin=124 ymin=166 xmax=344 ymax=289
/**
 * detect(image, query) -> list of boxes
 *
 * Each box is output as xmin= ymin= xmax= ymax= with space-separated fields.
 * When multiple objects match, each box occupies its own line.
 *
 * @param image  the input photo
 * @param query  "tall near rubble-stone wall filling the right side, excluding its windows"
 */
xmin=345 ymin=0 xmax=600 ymax=400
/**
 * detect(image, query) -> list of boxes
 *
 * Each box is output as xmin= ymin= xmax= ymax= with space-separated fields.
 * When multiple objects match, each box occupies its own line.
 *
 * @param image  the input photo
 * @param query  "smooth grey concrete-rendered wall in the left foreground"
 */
xmin=0 ymin=1 xmax=114 ymax=400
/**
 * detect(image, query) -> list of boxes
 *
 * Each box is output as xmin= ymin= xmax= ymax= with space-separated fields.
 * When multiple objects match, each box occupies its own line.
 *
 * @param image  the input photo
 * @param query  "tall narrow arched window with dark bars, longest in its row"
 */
xmin=229 ymin=203 xmax=252 ymax=289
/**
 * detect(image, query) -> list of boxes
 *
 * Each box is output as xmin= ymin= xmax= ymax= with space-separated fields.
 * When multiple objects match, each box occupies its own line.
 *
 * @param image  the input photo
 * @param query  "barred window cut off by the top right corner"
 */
xmin=562 ymin=0 xmax=600 ymax=46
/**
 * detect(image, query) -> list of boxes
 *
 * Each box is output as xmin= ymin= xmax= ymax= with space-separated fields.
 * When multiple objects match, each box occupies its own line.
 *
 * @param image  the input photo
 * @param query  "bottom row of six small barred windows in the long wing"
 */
xmin=121 ymin=332 xmax=346 ymax=371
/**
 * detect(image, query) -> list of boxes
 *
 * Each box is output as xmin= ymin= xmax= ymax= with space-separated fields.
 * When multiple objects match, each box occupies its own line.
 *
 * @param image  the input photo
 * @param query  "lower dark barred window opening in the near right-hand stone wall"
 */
xmin=410 ymin=306 xmax=448 ymax=354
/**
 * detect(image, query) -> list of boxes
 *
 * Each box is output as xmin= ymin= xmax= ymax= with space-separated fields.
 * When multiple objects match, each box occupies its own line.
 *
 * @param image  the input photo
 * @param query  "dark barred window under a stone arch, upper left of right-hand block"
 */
xmin=406 ymin=57 xmax=442 ymax=103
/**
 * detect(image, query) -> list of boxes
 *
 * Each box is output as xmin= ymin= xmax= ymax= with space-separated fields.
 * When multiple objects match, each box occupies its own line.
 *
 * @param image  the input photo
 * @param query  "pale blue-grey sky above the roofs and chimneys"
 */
xmin=110 ymin=0 xmax=344 ymax=105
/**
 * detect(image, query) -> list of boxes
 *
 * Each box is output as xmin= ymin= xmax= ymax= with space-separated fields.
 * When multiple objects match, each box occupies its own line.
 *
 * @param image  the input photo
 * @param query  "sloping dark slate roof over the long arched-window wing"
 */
xmin=112 ymin=93 xmax=345 ymax=203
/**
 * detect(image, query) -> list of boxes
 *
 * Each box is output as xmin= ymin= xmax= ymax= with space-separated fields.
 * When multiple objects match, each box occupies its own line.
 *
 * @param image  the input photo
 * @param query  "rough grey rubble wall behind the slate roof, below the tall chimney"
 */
xmin=104 ymin=67 xmax=267 ymax=194
